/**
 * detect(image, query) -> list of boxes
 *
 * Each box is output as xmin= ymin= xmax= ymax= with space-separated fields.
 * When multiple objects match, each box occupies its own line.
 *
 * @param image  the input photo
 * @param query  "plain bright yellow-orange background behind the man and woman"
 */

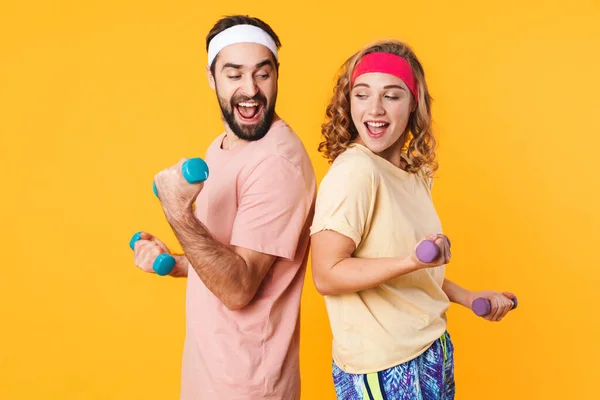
xmin=0 ymin=0 xmax=600 ymax=400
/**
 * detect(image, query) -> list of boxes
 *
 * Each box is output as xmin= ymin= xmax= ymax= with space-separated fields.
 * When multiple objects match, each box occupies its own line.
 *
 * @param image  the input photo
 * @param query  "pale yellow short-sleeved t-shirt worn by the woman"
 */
xmin=311 ymin=144 xmax=450 ymax=374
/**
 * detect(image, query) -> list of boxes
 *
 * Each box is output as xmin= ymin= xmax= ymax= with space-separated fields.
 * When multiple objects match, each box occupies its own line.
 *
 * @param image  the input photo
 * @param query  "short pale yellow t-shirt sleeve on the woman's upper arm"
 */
xmin=310 ymin=158 xmax=377 ymax=247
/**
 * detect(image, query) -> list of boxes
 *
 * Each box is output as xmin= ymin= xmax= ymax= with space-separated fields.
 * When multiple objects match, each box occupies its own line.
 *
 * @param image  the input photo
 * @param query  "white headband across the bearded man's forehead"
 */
xmin=208 ymin=25 xmax=277 ymax=65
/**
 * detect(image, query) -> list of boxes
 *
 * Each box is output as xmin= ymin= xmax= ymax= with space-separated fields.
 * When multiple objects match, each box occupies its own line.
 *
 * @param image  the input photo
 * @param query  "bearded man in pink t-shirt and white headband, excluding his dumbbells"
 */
xmin=135 ymin=16 xmax=316 ymax=400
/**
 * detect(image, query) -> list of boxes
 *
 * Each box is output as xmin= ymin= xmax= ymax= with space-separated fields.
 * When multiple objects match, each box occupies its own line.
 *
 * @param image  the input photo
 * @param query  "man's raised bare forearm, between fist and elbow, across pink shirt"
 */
xmin=168 ymin=210 xmax=247 ymax=308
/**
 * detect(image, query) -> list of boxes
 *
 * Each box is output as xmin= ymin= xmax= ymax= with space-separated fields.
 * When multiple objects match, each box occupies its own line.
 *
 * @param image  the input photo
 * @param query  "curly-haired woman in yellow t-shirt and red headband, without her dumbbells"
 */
xmin=311 ymin=41 xmax=514 ymax=399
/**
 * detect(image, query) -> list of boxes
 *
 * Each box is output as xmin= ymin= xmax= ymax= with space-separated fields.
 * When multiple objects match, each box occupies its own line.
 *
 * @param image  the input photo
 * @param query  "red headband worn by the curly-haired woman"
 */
xmin=352 ymin=52 xmax=419 ymax=102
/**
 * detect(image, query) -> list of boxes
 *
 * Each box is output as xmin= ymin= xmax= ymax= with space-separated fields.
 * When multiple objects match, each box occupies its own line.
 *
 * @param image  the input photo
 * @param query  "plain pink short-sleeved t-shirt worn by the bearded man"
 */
xmin=181 ymin=120 xmax=316 ymax=400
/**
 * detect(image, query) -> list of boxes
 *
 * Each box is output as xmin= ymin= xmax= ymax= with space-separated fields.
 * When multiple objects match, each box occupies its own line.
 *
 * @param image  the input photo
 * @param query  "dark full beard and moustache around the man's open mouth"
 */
xmin=217 ymin=90 xmax=277 ymax=141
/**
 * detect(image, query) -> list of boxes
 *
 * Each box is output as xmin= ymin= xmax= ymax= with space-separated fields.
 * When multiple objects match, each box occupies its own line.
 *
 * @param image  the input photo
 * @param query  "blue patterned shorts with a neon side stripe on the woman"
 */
xmin=333 ymin=332 xmax=455 ymax=400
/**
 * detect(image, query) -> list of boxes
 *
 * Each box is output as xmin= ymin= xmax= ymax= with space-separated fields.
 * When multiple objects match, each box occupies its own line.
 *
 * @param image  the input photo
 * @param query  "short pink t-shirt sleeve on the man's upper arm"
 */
xmin=231 ymin=156 xmax=313 ymax=260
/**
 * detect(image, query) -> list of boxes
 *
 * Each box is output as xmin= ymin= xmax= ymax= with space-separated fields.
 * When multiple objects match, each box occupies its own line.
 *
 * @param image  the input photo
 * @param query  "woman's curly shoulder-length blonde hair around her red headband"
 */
xmin=319 ymin=40 xmax=438 ymax=176
